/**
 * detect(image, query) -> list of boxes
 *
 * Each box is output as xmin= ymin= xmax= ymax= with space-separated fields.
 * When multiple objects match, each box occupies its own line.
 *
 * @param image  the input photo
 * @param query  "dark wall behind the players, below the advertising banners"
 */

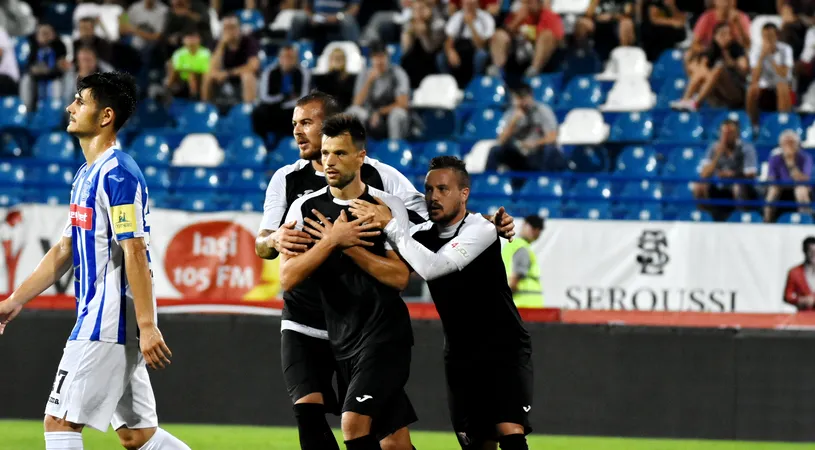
xmin=0 ymin=311 xmax=815 ymax=441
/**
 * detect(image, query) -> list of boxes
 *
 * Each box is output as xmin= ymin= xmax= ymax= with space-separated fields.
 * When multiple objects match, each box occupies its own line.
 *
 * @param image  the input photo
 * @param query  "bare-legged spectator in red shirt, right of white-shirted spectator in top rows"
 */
xmin=489 ymin=0 xmax=563 ymax=78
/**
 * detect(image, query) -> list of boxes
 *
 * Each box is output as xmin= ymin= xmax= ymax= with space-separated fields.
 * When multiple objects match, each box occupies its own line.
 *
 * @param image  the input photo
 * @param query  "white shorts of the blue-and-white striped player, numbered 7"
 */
xmin=45 ymin=341 xmax=158 ymax=432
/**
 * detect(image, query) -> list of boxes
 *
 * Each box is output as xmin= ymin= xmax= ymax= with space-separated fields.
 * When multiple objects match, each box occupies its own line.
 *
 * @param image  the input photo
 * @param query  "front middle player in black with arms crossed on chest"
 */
xmin=280 ymin=114 xmax=420 ymax=450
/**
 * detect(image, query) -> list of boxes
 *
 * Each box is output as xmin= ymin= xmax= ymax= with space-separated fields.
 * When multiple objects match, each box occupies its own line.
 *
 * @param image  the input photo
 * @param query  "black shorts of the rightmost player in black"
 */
xmin=444 ymin=353 xmax=533 ymax=448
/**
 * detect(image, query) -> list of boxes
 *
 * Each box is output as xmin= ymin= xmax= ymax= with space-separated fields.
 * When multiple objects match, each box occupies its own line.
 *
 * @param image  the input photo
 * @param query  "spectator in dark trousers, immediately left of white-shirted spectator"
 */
xmin=402 ymin=0 xmax=445 ymax=89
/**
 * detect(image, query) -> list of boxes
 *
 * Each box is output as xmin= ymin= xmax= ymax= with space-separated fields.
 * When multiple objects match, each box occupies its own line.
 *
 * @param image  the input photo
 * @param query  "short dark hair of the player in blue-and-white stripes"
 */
xmin=76 ymin=72 xmax=137 ymax=131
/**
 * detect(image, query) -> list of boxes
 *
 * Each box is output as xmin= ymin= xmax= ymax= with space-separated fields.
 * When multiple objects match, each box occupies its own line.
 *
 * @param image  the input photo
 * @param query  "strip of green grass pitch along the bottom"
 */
xmin=0 ymin=420 xmax=812 ymax=450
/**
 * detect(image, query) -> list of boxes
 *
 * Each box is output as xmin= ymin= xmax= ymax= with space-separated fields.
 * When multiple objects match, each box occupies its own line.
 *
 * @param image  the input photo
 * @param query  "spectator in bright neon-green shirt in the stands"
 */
xmin=165 ymin=26 xmax=212 ymax=100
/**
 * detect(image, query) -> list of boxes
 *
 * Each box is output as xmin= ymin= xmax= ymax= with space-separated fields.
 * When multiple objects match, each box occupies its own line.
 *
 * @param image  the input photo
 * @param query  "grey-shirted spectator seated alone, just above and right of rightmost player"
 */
xmin=486 ymin=84 xmax=566 ymax=172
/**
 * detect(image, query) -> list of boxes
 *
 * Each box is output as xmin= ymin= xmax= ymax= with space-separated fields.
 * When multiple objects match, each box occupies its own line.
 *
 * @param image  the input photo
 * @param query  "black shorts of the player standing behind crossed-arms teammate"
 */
xmin=280 ymin=330 xmax=340 ymax=414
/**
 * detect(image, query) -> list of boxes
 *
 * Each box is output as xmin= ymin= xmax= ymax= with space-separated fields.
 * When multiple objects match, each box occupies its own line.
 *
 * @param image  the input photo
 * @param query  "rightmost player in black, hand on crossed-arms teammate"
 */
xmin=351 ymin=156 xmax=532 ymax=450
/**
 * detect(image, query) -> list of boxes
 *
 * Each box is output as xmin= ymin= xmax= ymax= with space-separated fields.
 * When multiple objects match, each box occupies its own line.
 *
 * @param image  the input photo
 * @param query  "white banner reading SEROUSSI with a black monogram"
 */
xmin=534 ymin=220 xmax=815 ymax=312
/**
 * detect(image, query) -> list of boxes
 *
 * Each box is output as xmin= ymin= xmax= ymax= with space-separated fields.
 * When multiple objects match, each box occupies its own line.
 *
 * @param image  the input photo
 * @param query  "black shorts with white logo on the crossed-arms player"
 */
xmin=337 ymin=346 xmax=418 ymax=440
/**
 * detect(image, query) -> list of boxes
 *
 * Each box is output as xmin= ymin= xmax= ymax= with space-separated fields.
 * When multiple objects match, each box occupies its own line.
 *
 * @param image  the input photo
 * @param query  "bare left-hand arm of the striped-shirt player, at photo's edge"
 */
xmin=0 ymin=236 xmax=73 ymax=334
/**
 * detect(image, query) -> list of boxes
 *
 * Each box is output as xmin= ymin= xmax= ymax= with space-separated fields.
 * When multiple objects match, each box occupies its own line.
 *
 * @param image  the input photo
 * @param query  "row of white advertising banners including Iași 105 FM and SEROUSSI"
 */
xmin=0 ymin=205 xmax=815 ymax=312
